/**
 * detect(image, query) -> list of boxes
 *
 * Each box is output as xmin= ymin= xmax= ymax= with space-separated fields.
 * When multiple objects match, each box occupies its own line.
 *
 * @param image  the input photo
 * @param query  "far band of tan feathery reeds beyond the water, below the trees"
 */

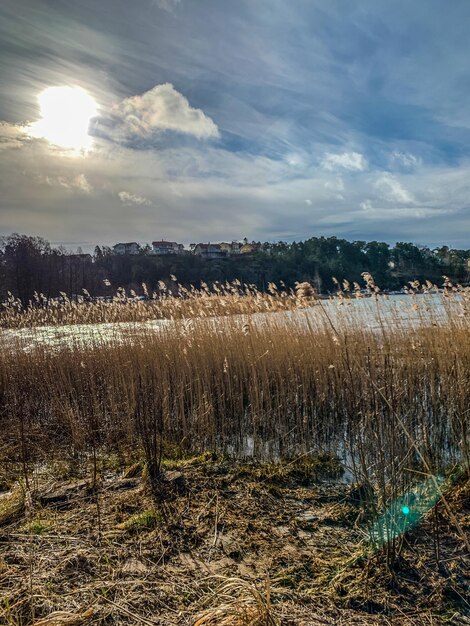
xmin=0 ymin=276 xmax=316 ymax=328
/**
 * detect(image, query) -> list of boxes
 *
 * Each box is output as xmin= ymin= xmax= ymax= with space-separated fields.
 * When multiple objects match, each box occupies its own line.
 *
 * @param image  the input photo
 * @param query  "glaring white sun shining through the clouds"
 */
xmin=29 ymin=86 xmax=98 ymax=152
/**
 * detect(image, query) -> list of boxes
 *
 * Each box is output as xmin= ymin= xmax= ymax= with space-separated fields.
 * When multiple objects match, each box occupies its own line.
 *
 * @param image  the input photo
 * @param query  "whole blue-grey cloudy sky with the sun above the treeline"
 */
xmin=0 ymin=0 xmax=470 ymax=250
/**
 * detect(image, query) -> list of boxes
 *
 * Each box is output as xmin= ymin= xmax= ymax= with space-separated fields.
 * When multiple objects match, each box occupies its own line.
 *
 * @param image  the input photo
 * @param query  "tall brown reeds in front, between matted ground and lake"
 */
xmin=0 ymin=277 xmax=470 ymax=560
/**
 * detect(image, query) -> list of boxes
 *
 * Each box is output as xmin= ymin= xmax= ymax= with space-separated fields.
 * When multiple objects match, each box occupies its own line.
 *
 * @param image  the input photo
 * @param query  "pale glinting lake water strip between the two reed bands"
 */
xmin=0 ymin=294 xmax=466 ymax=350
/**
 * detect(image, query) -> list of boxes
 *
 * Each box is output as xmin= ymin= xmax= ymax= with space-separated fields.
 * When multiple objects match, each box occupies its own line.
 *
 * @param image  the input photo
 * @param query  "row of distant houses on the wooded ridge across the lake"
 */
xmin=112 ymin=238 xmax=262 ymax=259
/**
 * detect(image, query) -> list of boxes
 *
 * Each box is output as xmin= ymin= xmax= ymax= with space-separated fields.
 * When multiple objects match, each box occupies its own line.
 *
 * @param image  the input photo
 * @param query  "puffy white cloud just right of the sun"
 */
xmin=113 ymin=83 xmax=219 ymax=139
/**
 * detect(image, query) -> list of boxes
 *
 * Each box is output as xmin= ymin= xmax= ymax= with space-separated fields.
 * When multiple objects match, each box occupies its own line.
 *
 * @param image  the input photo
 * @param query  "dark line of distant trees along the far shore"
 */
xmin=0 ymin=233 xmax=470 ymax=302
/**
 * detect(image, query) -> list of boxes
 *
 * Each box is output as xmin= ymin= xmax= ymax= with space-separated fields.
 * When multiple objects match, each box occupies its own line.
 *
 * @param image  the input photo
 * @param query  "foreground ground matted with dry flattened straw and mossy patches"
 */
xmin=0 ymin=455 xmax=470 ymax=626
